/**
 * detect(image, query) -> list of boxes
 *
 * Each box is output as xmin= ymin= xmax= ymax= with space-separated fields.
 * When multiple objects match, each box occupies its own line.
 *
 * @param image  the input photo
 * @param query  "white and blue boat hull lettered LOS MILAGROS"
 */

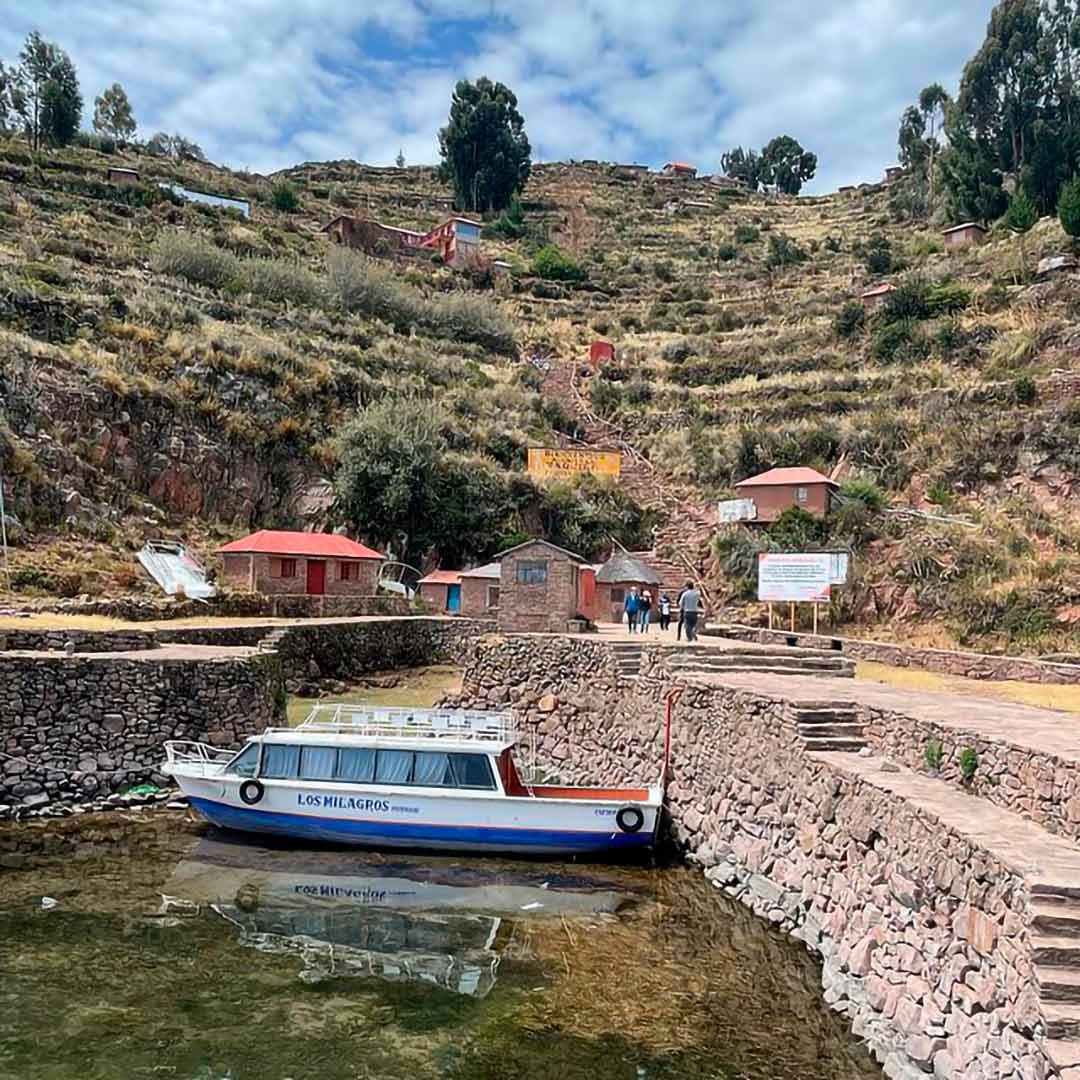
xmin=172 ymin=769 xmax=660 ymax=855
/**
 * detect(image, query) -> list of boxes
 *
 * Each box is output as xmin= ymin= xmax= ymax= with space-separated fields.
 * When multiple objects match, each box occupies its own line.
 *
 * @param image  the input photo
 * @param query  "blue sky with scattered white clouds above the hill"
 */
xmin=0 ymin=0 xmax=993 ymax=191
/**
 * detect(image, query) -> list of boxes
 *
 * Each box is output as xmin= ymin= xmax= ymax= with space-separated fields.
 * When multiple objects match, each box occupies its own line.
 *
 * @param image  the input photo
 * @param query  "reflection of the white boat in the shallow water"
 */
xmin=164 ymin=839 xmax=642 ymax=997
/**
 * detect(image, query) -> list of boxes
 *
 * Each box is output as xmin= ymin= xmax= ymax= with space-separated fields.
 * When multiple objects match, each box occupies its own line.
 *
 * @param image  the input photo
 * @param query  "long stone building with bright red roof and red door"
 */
xmin=218 ymin=529 xmax=384 ymax=596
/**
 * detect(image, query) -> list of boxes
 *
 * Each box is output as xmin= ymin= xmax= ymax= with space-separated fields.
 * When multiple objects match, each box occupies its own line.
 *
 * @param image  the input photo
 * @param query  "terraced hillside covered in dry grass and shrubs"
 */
xmin=0 ymin=144 xmax=1080 ymax=651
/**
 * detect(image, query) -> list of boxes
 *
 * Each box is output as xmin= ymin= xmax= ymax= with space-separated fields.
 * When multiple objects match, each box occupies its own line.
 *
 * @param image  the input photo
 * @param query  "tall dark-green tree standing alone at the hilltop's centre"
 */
xmin=438 ymin=77 xmax=531 ymax=213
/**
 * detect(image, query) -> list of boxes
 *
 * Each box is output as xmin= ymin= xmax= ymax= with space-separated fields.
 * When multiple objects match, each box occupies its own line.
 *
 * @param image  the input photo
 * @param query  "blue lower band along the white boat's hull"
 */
xmin=189 ymin=797 xmax=652 ymax=854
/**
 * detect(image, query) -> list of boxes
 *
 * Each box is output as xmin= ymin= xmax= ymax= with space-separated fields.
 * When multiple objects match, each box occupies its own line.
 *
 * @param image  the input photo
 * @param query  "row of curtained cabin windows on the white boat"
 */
xmin=257 ymin=743 xmax=495 ymax=791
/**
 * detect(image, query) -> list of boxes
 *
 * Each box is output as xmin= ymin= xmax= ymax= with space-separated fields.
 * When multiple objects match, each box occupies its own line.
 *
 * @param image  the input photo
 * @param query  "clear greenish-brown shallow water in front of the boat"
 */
xmin=0 ymin=813 xmax=881 ymax=1080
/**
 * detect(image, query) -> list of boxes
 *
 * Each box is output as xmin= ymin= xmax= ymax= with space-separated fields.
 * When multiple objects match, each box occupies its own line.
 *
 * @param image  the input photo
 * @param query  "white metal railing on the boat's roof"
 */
xmin=274 ymin=703 xmax=518 ymax=744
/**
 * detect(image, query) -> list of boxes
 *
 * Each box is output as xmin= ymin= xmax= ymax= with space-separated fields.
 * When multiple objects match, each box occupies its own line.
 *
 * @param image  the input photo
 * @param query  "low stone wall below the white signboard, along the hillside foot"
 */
xmin=706 ymin=625 xmax=1080 ymax=686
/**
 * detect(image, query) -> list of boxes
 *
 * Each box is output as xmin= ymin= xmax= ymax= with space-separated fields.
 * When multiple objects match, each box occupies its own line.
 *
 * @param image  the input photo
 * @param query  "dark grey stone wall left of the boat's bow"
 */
xmin=0 ymin=653 xmax=284 ymax=806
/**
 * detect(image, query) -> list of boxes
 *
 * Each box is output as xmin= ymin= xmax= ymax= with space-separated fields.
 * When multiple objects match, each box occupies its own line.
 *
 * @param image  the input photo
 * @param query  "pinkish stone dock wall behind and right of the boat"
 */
xmin=442 ymin=638 xmax=1048 ymax=1080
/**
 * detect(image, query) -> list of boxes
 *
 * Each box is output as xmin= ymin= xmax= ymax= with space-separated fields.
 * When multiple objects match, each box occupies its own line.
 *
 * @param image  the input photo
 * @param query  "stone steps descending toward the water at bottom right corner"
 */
xmin=1031 ymin=883 xmax=1080 ymax=1080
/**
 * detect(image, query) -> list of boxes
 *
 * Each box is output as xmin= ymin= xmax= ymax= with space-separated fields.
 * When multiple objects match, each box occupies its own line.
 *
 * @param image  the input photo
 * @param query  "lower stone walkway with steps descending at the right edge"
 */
xmin=814 ymin=753 xmax=1080 ymax=1080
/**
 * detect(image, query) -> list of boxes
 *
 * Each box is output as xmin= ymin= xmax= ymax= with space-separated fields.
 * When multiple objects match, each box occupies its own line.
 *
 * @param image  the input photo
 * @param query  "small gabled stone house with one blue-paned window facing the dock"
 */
xmin=499 ymin=540 xmax=588 ymax=634
